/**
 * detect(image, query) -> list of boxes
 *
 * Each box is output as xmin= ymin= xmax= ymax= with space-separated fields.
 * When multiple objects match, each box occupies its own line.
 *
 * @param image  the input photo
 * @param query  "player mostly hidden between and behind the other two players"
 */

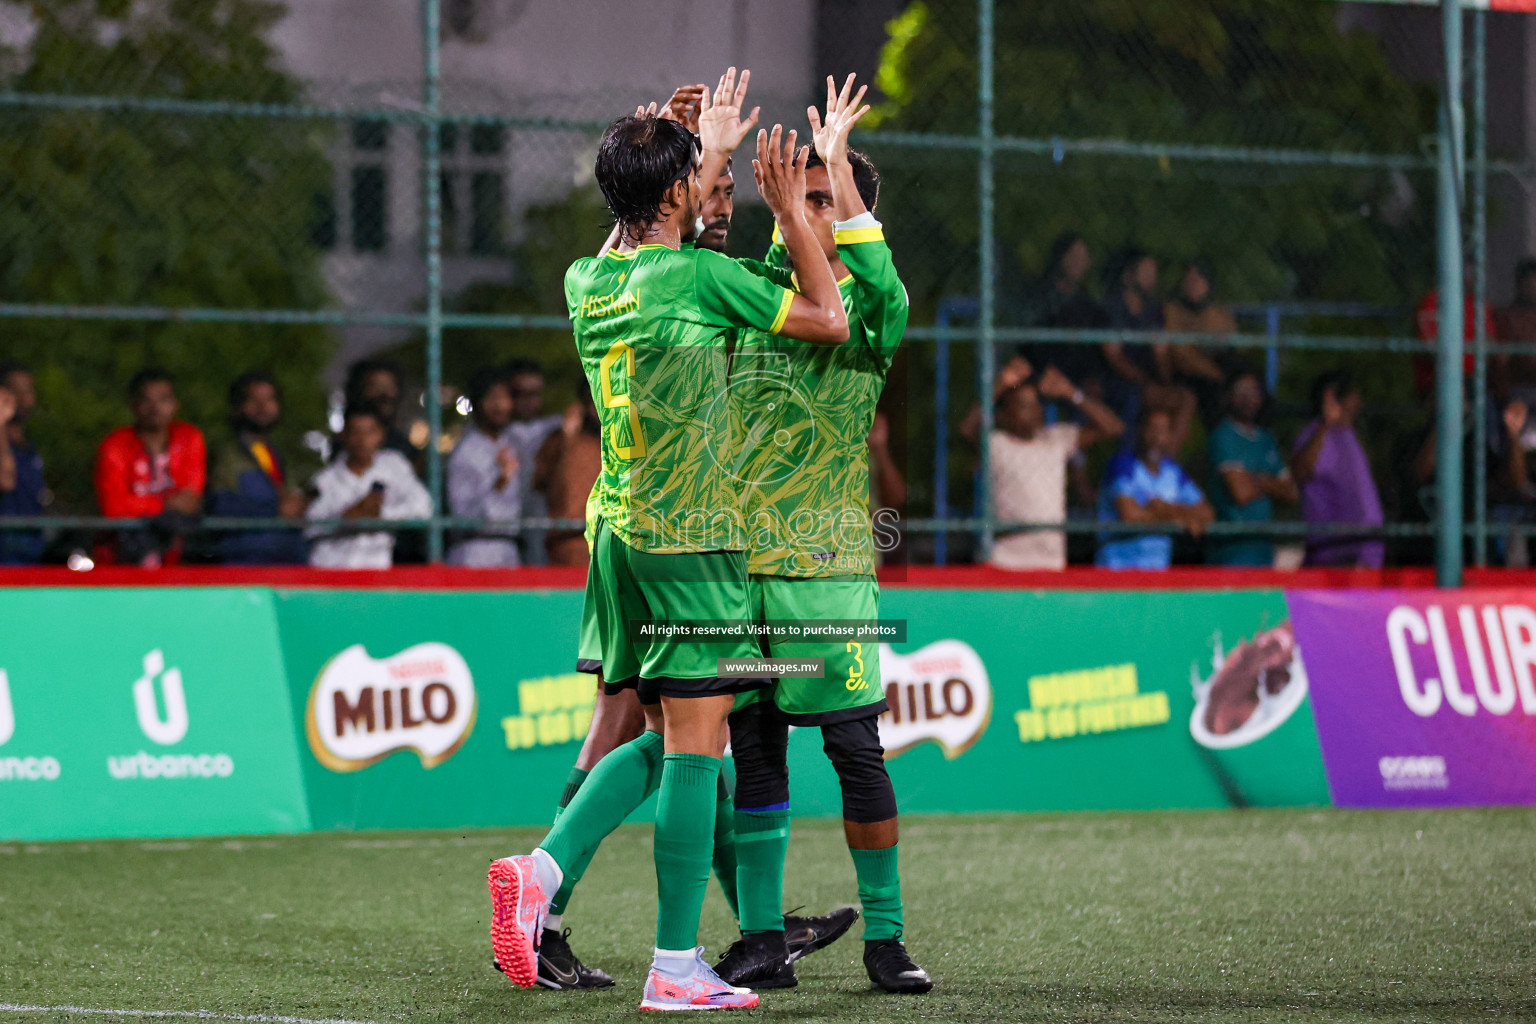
xmin=538 ymin=68 xmax=859 ymax=989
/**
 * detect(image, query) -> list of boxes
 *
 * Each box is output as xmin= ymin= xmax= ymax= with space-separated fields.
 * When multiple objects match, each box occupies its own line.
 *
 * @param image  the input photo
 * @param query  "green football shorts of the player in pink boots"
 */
xmin=582 ymin=522 xmax=771 ymax=705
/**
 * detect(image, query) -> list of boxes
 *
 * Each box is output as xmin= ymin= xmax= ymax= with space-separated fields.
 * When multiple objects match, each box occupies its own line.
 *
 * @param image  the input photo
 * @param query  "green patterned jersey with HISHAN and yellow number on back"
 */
xmin=565 ymin=246 xmax=794 ymax=554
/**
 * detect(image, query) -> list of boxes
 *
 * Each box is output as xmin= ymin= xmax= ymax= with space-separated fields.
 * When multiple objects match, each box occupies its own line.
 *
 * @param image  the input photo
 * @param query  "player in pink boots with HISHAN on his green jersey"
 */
xmin=487 ymin=85 xmax=848 ymax=1010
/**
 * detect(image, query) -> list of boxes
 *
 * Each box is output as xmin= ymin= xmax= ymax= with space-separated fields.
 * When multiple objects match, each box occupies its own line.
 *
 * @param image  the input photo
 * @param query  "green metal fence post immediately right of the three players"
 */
xmin=975 ymin=0 xmax=997 ymax=562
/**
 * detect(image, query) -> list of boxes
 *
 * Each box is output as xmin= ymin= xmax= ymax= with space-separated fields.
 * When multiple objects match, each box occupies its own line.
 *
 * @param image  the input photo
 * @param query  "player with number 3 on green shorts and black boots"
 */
xmin=716 ymin=75 xmax=932 ymax=993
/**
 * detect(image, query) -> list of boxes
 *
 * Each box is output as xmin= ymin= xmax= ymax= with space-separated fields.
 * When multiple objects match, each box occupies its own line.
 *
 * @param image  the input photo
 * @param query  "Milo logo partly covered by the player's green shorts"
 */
xmin=880 ymin=640 xmax=992 ymax=760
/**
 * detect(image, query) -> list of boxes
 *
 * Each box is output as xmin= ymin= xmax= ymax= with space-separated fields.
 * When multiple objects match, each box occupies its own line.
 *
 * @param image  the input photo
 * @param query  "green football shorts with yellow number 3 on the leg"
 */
xmin=736 ymin=573 xmax=886 ymax=726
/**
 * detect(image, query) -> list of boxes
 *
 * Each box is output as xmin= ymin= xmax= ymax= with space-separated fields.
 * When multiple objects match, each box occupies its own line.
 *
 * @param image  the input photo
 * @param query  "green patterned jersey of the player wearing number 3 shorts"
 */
xmin=731 ymin=218 xmax=908 ymax=577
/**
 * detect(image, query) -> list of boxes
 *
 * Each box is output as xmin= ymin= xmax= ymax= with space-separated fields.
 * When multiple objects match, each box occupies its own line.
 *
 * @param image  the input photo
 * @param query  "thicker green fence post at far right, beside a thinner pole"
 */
xmin=1435 ymin=0 xmax=1464 ymax=586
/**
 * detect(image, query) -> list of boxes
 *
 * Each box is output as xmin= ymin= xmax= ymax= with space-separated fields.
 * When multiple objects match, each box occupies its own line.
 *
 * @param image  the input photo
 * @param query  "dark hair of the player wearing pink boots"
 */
xmin=598 ymin=117 xmax=713 ymax=241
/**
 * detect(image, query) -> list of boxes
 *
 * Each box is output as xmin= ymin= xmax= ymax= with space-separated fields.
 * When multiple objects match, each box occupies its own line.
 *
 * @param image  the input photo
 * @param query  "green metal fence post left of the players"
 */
xmin=421 ymin=0 xmax=444 ymax=563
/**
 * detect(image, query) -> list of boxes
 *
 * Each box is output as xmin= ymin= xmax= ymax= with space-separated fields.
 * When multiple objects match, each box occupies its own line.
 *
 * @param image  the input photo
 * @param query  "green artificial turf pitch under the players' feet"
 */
xmin=0 ymin=809 xmax=1536 ymax=1024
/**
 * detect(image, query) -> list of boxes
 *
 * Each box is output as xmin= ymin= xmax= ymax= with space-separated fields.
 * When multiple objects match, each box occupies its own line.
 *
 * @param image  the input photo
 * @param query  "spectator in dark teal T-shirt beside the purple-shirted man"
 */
xmin=1206 ymin=370 xmax=1299 ymax=567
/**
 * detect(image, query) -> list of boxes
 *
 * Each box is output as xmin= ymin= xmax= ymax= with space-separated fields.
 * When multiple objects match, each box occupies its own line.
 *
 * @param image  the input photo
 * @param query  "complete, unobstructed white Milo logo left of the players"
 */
xmin=304 ymin=643 xmax=476 ymax=772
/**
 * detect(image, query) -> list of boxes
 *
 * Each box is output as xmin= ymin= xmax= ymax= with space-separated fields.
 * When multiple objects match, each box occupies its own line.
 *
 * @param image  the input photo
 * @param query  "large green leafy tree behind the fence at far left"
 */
xmin=0 ymin=0 xmax=332 ymax=511
